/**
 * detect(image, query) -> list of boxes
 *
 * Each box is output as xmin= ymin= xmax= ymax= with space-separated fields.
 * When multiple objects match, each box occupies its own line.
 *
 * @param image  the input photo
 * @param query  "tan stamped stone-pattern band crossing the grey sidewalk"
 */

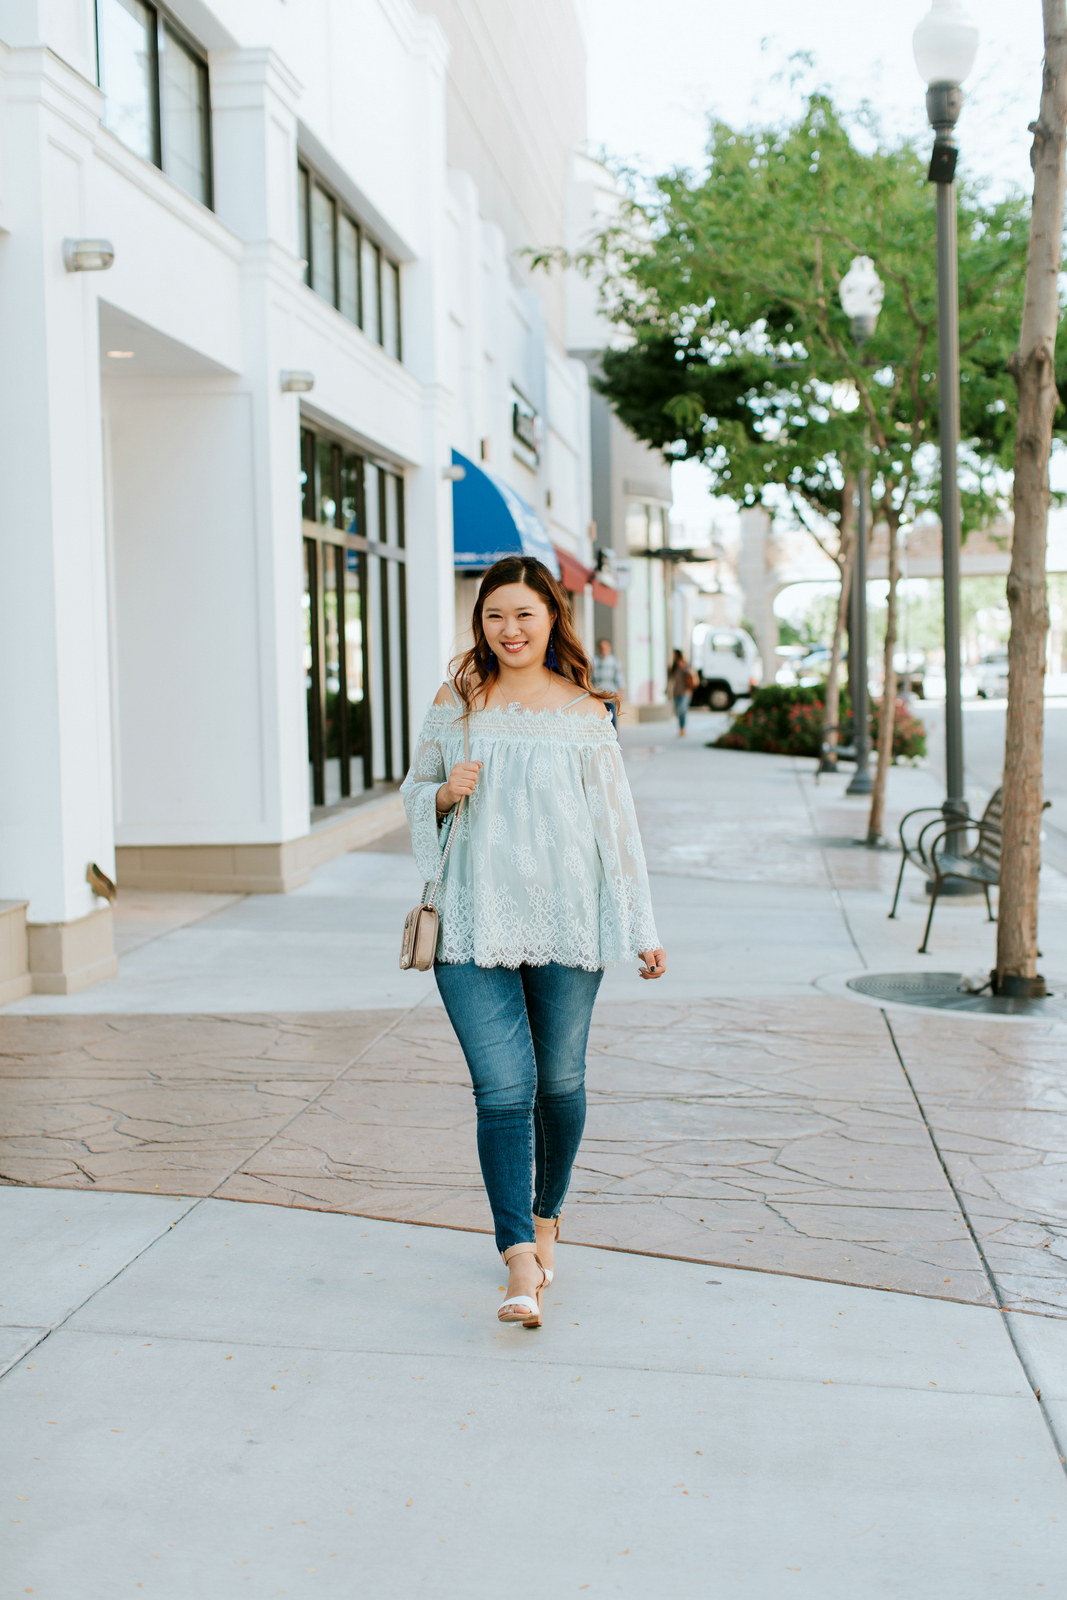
xmin=0 ymin=997 xmax=1067 ymax=1317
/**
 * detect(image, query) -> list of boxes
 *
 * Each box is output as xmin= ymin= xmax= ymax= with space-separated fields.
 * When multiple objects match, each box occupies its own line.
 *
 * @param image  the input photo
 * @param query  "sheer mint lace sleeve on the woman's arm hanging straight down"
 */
xmin=582 ymin=742 xmax=659 ymax=965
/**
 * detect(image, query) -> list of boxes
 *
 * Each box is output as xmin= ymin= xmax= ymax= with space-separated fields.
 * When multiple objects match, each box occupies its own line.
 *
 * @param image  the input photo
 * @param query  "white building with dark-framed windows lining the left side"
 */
xmin=0 ymin=0 xmax=592 ymax=1002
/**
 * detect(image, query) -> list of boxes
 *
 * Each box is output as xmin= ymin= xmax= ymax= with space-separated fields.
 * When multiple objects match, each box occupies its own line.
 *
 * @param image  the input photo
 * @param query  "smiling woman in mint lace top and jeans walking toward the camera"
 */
xmin=402 ymin=557 xmax=667 ymax=1328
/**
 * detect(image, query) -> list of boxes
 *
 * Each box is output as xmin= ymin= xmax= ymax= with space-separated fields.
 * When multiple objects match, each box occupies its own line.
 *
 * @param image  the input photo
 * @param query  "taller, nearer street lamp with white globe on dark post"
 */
xmin=912 ymin=0 xmax=977 ymax=821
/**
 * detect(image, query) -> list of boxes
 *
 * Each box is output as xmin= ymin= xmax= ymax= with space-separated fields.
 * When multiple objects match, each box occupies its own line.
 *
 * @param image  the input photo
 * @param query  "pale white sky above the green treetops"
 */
xmin=587 ymin=0 xmax=1041 ymax=190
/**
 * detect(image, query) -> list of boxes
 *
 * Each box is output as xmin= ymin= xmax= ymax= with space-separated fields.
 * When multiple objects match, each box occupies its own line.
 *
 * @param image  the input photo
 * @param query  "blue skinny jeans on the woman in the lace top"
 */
xmin=434 ymin=962 xmax=603 ymax=1251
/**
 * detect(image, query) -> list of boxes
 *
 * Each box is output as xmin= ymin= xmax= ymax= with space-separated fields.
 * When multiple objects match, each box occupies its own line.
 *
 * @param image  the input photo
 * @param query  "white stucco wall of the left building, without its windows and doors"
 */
xmin=0 ymin=0 xmax=590 ymax=922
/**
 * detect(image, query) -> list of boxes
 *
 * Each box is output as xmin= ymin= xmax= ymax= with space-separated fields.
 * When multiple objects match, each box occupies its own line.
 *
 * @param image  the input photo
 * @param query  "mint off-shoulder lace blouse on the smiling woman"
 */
xmin=400 ymin=684 xmax=659 ymax=971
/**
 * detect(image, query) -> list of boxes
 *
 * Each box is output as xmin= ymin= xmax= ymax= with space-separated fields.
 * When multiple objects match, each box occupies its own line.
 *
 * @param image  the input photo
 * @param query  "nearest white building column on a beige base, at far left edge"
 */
xmin=0 ymin=46 xmax=118 ymax=998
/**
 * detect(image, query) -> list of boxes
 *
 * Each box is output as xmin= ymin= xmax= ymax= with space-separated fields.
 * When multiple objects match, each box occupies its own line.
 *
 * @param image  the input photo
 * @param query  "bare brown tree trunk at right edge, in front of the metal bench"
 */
xmin=995 ymin=0 xmax=1067 ymax=994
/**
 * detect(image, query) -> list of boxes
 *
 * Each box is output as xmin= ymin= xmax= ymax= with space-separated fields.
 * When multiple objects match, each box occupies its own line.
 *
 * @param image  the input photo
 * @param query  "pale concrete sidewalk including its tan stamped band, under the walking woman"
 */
xmin=0 ymin=717 xmax=1067 ymax=1600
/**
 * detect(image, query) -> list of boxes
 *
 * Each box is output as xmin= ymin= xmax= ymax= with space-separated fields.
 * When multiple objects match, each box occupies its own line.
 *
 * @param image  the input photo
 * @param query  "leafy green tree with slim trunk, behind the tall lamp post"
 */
xmin=582 ymin=94 xmax=1027 ymax=837
